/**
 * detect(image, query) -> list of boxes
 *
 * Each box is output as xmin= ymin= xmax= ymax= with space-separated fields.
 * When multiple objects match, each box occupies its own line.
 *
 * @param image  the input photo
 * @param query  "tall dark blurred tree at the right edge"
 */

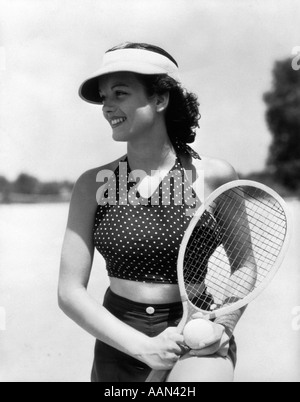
xmin=263 ymin=58 xmax=300 ymax=194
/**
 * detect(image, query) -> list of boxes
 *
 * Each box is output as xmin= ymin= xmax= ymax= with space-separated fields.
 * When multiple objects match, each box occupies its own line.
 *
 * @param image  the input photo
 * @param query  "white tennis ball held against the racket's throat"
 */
xmin=183 ymin=318 xmax=214 ymax=349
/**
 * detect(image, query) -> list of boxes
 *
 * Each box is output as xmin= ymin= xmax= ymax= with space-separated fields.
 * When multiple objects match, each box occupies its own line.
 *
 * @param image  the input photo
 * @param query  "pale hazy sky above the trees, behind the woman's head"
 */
xmin=0 ymin=0 xmax=300 ymax=180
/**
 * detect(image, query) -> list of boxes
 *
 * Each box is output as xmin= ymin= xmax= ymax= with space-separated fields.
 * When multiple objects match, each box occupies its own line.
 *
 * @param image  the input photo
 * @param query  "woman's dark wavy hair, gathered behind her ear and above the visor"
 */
xmin=106 ymin=42 xmax=201 ymax=148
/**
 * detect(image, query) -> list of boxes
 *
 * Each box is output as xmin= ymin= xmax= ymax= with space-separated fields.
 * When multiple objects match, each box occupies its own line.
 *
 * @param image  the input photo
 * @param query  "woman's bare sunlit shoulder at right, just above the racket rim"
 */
xmin=197 ymin=156 xmax=238 ymax=190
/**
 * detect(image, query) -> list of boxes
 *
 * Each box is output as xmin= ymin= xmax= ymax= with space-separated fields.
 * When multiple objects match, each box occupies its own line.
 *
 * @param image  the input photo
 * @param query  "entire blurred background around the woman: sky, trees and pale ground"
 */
xmin=0 ymin=0 xmax=300 ymax=382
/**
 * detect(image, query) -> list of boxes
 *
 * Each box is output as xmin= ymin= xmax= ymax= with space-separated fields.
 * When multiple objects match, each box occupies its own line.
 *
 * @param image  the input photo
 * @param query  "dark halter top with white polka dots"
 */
xmin=94 ymin=153 xmax=223 ymax=284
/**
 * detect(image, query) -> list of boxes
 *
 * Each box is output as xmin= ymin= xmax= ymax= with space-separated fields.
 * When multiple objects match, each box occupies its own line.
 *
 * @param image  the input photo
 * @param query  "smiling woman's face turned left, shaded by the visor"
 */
xmin=99 ymin=72 xmax=157 ymax=141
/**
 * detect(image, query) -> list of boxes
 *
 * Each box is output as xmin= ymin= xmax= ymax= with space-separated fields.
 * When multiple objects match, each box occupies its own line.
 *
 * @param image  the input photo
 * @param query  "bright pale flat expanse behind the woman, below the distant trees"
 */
xmin=0 ymin=201 xmax=300 ymax=382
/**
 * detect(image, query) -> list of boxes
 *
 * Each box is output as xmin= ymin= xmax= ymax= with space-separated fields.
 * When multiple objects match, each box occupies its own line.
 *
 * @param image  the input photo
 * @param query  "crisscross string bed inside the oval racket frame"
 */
xmin=183 ymin=187 xmax=286 ymax=310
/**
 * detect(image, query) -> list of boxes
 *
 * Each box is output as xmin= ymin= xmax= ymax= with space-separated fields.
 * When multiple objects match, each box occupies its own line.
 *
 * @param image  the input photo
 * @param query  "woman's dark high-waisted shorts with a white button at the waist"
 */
xmin=91 ymin=289 xmax=236 ymax=382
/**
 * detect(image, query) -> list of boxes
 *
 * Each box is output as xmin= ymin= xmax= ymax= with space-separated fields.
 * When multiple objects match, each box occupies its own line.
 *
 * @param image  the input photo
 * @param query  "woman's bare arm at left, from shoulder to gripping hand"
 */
xmin=58 ymin=167 xmax=182 ymax=369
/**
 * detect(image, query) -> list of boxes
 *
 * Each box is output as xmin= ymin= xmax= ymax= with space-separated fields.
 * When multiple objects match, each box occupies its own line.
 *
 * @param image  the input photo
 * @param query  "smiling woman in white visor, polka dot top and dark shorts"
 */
xmin=59 ymin=43 xmax=241 ymax=382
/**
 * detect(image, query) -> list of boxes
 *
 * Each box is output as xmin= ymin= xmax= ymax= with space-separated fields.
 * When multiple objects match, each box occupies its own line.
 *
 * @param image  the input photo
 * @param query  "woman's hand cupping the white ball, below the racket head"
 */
xmin=189 ymin=313 xmax=230 ymax=357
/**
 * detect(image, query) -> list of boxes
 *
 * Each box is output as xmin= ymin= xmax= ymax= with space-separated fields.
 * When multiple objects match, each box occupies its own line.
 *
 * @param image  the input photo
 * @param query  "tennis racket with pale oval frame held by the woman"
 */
xmin=146 ymin=180 xmax=290 ymax=382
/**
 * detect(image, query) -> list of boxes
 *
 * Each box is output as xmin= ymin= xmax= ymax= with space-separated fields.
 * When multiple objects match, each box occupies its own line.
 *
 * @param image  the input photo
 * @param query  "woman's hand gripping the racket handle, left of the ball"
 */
xmin=139 ymin=327 xmax=187 ymax=370
